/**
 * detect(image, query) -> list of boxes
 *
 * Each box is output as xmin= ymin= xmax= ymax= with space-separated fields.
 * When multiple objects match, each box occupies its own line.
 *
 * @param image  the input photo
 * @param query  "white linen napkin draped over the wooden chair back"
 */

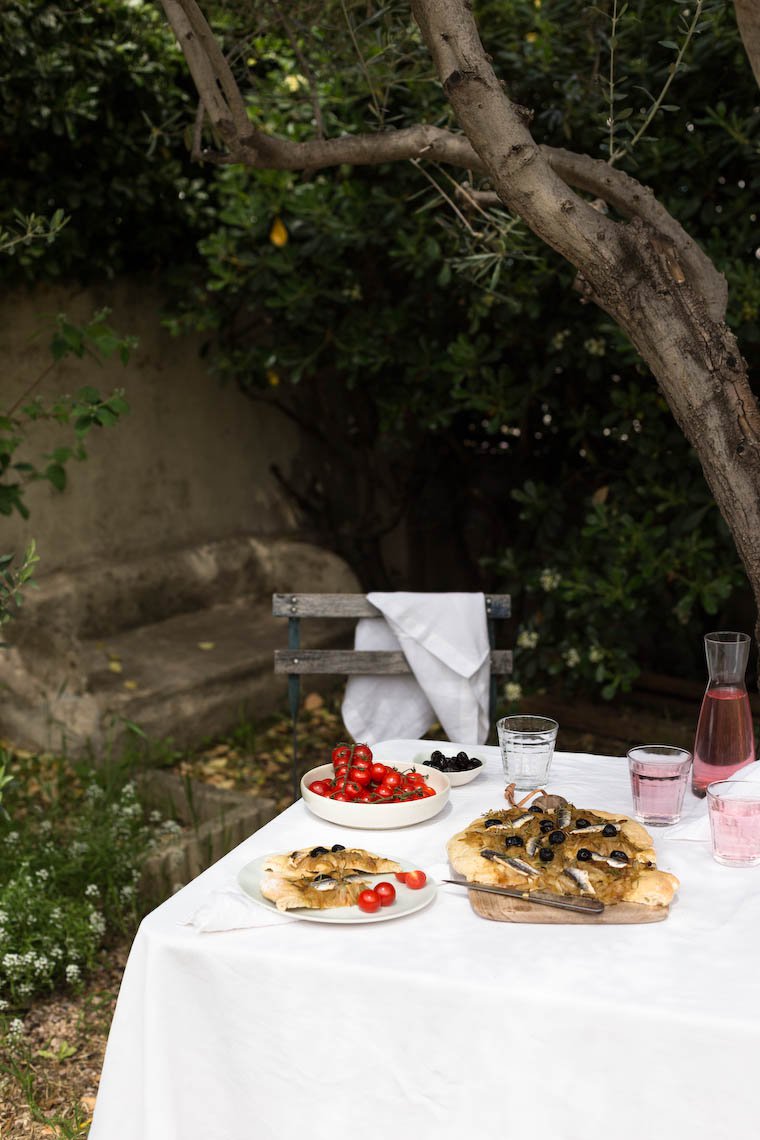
xmin=343 ymin=592 xmax=490 ymax=744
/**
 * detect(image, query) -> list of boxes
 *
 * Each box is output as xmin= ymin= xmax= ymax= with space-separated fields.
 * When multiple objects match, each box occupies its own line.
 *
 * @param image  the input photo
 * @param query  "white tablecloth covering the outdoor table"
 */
xmin=90 ymin=748 xmax=760 ymax=1140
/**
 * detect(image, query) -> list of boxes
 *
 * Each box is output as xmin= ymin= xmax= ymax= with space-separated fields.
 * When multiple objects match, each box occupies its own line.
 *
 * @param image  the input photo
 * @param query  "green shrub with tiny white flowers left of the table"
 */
xmin=0 ymin=754 xmax=158 ymax=1008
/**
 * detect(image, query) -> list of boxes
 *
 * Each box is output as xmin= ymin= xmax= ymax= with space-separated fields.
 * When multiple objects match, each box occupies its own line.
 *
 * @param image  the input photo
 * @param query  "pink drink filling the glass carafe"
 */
xmin=693 ymin=684 xmax=754 ymax=796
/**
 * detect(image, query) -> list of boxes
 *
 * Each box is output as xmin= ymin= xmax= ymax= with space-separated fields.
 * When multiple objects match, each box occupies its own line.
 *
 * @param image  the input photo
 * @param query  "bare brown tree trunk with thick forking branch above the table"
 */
xmin=162 ymin=0 xmax=760 ymax=647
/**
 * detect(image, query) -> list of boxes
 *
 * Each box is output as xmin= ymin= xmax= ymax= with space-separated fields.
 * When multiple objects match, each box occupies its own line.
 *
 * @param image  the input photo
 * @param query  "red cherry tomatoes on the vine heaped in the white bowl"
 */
xmin=309 ymin=744 xmax=435 ymax=804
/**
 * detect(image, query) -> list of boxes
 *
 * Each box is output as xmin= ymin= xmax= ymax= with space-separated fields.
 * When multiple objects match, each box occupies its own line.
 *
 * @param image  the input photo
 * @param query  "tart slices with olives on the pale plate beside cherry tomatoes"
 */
xmin=261 ymin=844 xmax=401 ymax=911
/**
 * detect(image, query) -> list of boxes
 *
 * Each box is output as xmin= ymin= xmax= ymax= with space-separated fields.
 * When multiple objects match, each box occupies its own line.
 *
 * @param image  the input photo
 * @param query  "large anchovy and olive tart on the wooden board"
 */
xmin=448 ymin=796 xmax=679 ymax=906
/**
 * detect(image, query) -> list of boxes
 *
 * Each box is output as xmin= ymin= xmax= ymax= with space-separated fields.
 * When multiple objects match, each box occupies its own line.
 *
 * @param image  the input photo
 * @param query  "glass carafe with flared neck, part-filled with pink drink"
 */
xmin=692 ymin=633 xmax=754 ymax=796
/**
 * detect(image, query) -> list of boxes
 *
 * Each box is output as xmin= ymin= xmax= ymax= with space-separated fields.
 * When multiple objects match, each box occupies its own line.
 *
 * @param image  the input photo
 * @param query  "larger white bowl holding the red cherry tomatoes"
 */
xmin=301 ymin=764 xmax=451 ymax=831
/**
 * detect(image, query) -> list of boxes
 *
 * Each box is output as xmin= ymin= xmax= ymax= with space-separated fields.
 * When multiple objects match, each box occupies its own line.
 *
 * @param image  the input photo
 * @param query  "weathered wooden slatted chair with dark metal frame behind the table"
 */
xmin=272 ymin=594 xmax=512 ymax=799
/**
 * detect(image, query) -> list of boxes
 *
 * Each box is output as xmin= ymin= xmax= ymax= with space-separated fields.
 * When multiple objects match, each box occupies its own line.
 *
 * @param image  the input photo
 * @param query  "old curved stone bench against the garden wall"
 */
xmin=0 ymin=536 xmax=359 ymax=755
